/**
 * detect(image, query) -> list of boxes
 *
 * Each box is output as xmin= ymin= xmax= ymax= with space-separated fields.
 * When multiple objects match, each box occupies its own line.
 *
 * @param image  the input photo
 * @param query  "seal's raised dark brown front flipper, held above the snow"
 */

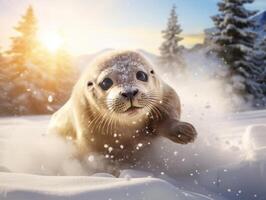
xmin=161 ymin=120 xmax=197 ymax=144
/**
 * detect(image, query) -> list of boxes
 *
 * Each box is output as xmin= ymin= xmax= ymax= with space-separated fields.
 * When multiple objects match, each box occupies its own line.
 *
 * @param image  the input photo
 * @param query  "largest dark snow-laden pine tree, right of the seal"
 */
xmin=212 ymin=0 xmax=261 ymax=108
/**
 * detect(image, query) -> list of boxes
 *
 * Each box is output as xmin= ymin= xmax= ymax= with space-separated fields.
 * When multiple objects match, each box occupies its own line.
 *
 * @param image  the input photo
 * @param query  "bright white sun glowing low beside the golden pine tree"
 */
xmin=40 ymin=31 xmax=64 ymax=53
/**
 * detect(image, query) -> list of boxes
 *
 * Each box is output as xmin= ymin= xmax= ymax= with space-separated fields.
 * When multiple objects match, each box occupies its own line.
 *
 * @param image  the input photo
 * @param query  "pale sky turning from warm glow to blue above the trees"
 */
xmin=0 ymin=0 xmax=266 ymax=55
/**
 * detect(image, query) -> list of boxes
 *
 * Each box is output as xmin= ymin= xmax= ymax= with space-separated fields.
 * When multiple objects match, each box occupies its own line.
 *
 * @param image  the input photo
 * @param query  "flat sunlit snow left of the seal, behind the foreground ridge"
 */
xmin=0 ymin=116 xmax=86 ymax=175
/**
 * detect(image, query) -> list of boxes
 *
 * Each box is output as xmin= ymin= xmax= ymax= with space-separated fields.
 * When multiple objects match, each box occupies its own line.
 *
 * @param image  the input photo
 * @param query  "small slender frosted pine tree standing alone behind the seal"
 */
xmin=160 ymin=6 xmax=184 ymax=71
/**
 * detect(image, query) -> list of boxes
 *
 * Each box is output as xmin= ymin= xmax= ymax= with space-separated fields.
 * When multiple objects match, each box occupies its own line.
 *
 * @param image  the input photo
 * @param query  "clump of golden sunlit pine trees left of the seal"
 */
xmin=0 ymin=6 xmax=77 ymax=115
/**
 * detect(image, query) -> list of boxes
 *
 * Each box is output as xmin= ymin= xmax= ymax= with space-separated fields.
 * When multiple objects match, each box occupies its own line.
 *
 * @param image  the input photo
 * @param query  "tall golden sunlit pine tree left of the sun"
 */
xmin=7 ymin=6 xmax=45 ymax=114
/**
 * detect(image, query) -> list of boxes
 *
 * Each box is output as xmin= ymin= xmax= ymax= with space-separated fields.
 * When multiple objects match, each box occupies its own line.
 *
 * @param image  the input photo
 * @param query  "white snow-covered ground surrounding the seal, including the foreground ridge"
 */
xmin=0 ymin=111 xmax=266 ymax=200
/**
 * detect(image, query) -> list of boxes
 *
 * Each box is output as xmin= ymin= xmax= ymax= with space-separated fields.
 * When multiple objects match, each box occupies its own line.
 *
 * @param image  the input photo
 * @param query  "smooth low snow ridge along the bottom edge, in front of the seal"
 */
xmin=0 ymin=173 xmax=210 ymax=200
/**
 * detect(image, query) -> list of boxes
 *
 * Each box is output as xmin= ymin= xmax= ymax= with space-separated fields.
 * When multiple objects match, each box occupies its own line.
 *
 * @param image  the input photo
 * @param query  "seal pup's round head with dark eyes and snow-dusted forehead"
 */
xmin=82 ymin=51 xmax=161 ymax=119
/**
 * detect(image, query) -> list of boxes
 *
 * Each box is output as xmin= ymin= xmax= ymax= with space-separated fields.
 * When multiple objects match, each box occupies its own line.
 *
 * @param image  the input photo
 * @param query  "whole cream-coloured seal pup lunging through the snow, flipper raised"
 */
xmin=49 ymin=51 xmax=197 ymax=166
